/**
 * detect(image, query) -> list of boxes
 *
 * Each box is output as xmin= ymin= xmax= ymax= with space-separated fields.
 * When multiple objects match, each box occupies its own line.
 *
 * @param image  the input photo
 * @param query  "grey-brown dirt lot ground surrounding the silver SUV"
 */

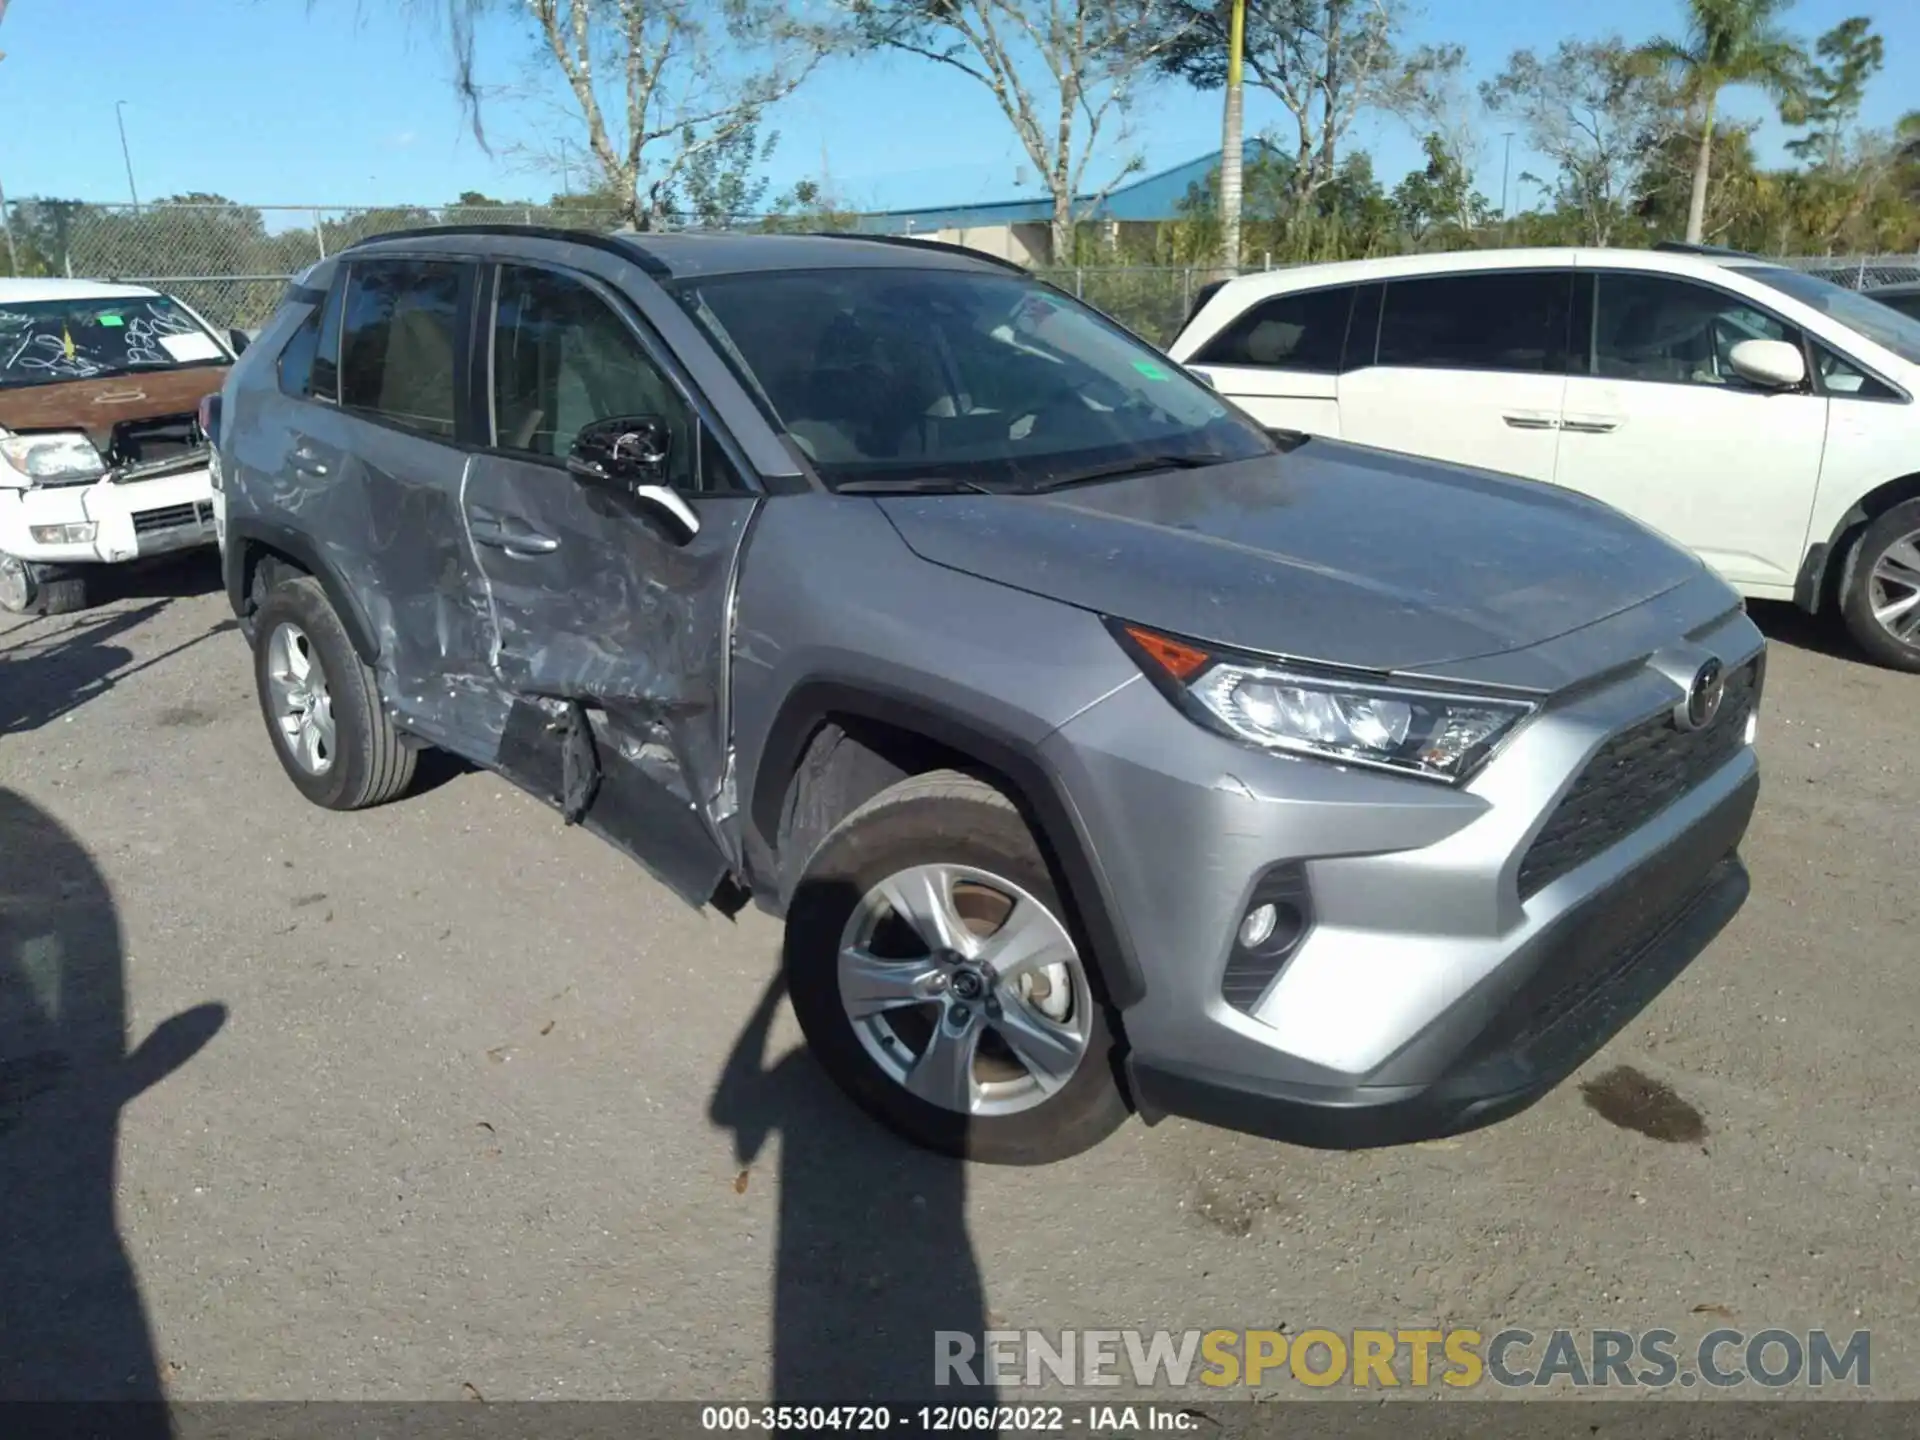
xmin=0 ymin=563 xmax=1920 ymax=1400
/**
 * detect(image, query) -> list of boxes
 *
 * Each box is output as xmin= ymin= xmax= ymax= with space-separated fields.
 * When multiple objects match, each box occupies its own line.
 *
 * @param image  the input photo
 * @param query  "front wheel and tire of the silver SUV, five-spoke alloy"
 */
xmin=785 ymin=770 xmax=1127 ymax=1165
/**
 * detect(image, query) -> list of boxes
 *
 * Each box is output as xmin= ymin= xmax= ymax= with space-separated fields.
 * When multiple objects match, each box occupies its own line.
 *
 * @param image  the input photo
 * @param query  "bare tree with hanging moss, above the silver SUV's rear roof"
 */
xmin=347 ymin=0 xmax=841 ymax=227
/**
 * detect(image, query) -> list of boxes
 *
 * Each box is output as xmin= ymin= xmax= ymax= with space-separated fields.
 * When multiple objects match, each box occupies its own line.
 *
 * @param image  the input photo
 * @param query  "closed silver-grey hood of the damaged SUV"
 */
xmin=881 ymin=440 xmax=1701 ymax=672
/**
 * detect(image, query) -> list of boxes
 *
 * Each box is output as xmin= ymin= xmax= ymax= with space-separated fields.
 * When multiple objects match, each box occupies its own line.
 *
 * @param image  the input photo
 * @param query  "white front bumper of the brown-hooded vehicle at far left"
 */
xmin=0 ymin=467 xmax=215 ymax=566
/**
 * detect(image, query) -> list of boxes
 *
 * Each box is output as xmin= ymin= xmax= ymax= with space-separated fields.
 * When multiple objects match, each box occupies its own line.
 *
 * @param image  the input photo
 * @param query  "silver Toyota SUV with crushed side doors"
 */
xmin=211 ymin=228 xmax=1764 ymax=1164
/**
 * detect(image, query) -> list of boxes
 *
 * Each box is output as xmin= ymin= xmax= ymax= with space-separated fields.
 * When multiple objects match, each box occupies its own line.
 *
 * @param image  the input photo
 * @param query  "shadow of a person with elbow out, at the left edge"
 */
xmin=0 ymin=789 xmax=227 ymax=1436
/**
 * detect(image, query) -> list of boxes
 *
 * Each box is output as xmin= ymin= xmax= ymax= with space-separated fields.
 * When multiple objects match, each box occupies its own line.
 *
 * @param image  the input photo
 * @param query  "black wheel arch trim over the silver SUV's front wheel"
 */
xmin=747 ymin=680 xmax=1146 ymax=1008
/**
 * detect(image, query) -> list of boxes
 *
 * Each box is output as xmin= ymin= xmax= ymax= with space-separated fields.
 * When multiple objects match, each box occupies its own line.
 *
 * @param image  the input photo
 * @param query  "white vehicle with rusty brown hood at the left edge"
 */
xmin=0 ymin=280 xmax=244 ymax=614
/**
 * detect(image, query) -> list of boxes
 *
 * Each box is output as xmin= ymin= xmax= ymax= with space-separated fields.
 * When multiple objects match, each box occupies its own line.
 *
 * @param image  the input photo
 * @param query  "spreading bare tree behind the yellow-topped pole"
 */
xmin=1152 ymin=0 xmax=1461 ymax=225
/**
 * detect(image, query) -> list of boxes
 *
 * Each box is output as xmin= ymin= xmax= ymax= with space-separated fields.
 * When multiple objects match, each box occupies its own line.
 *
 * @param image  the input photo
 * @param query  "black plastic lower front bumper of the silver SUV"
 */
xmin=1127 ymin=776 xmax=1759 ymax=1150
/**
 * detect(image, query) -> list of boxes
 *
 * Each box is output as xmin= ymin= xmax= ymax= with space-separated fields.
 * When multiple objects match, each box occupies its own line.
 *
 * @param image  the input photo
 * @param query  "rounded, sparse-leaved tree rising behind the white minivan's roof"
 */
xmin=1480 ymin=38 xmax=1680 ymax=246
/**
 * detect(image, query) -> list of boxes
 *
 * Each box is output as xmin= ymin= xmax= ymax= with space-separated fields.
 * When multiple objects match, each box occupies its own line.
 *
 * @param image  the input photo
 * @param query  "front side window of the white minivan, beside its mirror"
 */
xmin=1592 ymin=273 xmax=1799 ymax=388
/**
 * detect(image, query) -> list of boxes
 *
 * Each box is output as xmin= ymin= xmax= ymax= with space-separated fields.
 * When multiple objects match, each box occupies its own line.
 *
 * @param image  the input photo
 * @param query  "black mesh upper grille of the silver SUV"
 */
xmin=1521 ymin=657 xmax=1763 ymax=900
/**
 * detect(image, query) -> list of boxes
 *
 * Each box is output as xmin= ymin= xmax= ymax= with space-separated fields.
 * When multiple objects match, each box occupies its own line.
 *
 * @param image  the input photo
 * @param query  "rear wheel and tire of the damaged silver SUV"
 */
xmin=253 ymin=576 xmax=415 ymax=810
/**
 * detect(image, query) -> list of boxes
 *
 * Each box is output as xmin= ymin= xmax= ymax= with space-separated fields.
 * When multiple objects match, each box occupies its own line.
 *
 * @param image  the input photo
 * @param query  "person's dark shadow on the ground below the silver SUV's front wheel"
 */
xmin=708 ymin=977 xmax=996 ymax=1434
